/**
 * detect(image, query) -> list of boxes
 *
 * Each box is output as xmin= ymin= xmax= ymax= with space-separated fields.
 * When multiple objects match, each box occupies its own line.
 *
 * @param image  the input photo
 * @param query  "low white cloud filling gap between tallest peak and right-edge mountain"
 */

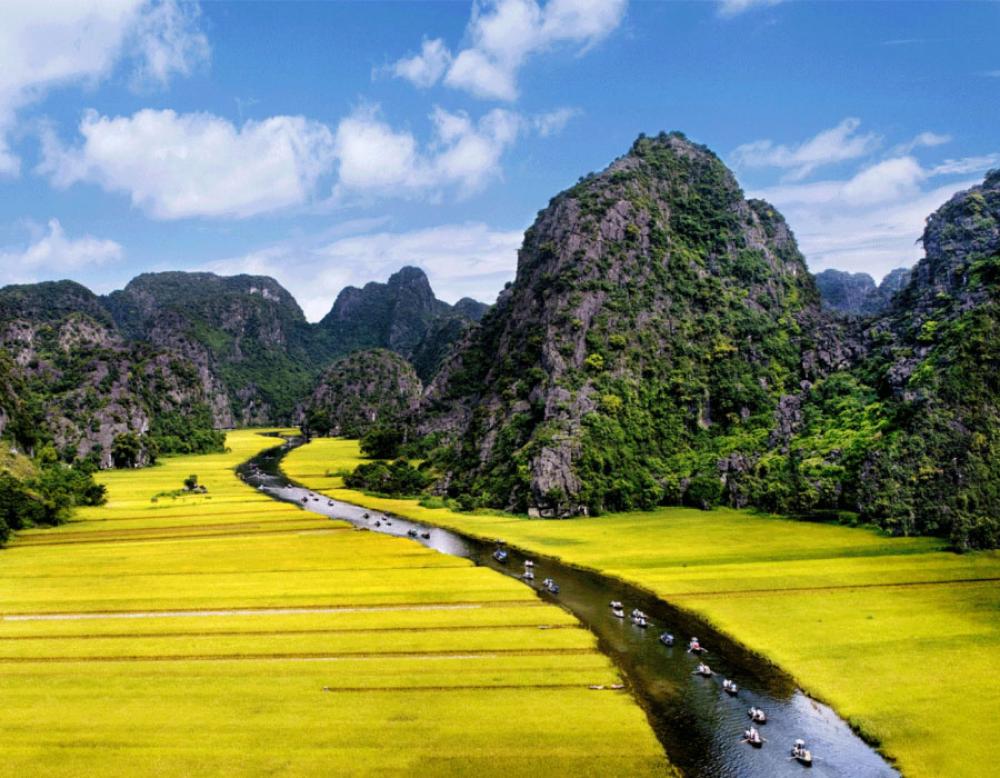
xmin=752 ymin=156 xmax=998 ymax=278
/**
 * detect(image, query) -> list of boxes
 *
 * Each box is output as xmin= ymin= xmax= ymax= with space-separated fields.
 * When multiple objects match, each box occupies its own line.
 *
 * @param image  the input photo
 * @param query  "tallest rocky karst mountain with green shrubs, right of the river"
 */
xmin=421 ymin=134 xmax=835 ymax=515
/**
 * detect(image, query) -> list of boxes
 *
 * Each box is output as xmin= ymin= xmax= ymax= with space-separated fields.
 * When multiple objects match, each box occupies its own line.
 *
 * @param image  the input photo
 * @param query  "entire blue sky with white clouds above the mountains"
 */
xmin=0 ymin=0 xmax=1000 ymax=319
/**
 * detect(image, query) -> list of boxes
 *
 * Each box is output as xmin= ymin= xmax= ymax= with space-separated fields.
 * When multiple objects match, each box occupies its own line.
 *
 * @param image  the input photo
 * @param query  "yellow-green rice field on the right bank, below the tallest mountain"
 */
xmin=285 ymin=439 xmax=1000 ymax=777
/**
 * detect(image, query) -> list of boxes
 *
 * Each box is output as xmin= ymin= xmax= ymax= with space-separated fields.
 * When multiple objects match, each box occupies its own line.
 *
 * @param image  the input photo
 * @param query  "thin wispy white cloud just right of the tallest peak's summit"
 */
xmin=732 ymin=118 xmax=881 ymax=181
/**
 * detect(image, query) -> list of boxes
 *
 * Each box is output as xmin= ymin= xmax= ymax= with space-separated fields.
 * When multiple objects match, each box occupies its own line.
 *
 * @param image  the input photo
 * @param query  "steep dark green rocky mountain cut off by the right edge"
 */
xmin=859 ymin=171 xmax=1000 ymax=548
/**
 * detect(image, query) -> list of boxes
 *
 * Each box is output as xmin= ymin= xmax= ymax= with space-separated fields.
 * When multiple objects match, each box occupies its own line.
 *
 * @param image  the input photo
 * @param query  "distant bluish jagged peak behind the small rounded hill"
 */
xmin=318 ymin=267 xmax=489 ymax=380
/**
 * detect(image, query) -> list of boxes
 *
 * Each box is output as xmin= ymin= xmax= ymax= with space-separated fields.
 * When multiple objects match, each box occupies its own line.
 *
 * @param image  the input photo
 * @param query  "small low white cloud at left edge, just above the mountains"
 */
xmin=0 ymin=219 xmax=124 ymax=284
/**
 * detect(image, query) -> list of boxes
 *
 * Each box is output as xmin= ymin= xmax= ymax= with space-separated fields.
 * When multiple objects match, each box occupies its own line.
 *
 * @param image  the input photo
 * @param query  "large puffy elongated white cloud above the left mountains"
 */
xmin=40 ymin=109 xmax=334 ymax=219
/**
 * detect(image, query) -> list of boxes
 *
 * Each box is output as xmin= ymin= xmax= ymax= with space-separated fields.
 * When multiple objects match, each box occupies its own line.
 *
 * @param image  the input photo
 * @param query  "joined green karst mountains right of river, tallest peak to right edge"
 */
xmin=416 ymin=134 xmax=1000 ymax=548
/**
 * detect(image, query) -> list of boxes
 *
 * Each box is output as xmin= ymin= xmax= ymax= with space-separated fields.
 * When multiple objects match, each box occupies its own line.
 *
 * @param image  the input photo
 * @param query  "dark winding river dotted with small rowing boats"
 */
xmin=239 ymin=439 xmax=898 ymax=778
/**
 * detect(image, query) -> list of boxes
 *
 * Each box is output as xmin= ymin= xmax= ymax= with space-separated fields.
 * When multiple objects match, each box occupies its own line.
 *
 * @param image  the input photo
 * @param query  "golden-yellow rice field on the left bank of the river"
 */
xmin=0 ymin=431 xmax=670 ymax=778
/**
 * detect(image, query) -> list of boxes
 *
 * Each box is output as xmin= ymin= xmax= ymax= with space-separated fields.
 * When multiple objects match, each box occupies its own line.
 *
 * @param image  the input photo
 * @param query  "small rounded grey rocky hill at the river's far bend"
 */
xmin=303 ymin=349 xmax=423 ymax=438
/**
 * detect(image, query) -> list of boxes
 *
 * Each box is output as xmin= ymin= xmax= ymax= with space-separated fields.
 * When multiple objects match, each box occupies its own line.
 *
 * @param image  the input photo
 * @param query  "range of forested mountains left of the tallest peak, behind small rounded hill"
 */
xmin=0 ymin=267 xmax=488 ymax=466
